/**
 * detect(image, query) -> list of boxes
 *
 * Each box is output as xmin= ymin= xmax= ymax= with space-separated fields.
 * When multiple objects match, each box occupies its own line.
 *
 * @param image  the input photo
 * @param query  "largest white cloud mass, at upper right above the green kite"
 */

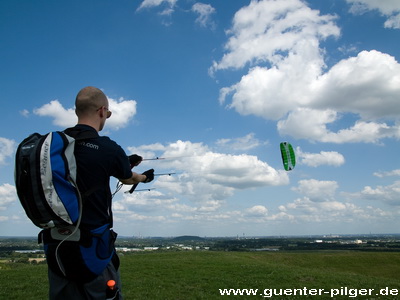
xmin=210 ymin=0 xmax=400 ymax=143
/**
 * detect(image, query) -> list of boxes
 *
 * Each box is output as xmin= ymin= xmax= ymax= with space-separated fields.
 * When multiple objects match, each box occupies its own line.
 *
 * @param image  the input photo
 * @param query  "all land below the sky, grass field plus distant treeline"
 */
xmin=0 ymin=235 xmax=400 ymax=300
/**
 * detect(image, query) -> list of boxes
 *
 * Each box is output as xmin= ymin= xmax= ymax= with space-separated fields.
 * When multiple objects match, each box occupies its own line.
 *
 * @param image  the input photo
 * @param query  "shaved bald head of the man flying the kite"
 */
xmin=75 ymin=86 xmax=108 ymax=118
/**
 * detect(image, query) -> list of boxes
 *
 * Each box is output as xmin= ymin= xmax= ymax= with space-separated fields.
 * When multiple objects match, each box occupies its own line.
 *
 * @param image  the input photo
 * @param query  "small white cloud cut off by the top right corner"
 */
xmin=347 ymin=0 xmax=400 ymax=29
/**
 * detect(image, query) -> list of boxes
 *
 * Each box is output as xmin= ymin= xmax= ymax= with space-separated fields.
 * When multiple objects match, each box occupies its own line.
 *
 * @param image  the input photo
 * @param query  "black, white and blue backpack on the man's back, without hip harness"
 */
xmin=15 ymin=131 xmax=96 ymax=235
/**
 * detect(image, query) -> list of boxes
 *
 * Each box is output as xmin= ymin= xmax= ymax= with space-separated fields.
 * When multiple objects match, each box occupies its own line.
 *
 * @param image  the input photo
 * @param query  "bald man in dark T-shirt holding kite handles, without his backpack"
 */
xmin=43 ymin=86 xmax=154 ymax=300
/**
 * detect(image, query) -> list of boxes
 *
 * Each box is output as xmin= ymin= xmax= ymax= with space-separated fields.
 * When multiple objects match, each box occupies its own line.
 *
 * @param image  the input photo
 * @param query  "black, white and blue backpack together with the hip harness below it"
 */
xmin=15 ymin=129 xmax=116 ymax=282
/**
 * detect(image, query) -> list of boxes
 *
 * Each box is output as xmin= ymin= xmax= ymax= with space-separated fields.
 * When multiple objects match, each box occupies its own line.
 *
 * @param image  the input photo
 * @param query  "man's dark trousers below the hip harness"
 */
xmin=48 ymin=261 xmax=122 ymax=300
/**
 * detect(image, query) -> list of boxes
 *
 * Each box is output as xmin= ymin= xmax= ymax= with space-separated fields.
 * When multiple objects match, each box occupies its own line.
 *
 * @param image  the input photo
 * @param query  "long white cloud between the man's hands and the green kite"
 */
xmin=122 ymin=140 xmax=289 ymax=212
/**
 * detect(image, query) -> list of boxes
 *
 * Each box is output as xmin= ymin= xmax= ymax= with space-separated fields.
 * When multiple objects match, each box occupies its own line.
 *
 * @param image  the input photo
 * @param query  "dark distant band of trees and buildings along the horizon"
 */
xmin=0 ymin=235 xmax=400 ymax=257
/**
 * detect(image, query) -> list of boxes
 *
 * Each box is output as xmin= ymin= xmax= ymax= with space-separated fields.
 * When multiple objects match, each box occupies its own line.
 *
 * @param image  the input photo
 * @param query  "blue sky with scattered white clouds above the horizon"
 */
xmin=0 ymin=0 xmax=400 ymax=236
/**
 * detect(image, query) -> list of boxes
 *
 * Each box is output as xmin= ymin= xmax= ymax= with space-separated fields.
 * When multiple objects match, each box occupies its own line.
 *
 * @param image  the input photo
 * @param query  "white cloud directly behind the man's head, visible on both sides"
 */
xmin=33 ymin=98 xmax=137 ymax=130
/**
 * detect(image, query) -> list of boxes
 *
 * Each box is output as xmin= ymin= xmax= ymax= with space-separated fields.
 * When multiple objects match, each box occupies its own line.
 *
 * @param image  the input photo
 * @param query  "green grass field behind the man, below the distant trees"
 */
xmin=0 ymin=251 xmax=400 ymax=300
